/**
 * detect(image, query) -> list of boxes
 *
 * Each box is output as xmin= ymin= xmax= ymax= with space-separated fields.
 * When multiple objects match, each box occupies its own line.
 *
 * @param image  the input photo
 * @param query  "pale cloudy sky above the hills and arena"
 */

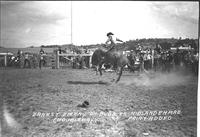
xmin=0 ymin=1 xmax=199 ymax=48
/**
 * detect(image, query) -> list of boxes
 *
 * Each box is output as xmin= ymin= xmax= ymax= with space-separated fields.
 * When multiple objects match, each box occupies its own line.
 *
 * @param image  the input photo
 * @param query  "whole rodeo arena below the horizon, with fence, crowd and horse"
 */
xmin=0 ymin=37 xmax=199 ymax=137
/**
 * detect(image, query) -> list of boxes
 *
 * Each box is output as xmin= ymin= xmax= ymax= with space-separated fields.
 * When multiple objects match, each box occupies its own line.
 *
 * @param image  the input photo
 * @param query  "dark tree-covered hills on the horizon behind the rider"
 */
xmin=32 ymin=37 xmax=199 ymax=51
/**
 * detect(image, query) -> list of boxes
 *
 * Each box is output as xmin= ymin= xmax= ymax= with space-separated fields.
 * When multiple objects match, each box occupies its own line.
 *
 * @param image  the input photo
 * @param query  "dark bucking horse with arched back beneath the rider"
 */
xmin=92 ymin=49 xmax=134 ymax=83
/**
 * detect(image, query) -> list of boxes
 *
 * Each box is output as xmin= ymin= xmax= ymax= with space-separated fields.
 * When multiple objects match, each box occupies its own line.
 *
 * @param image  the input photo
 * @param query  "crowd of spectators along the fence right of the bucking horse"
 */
xmin=127 ymin=44 xmax=199 ymax=75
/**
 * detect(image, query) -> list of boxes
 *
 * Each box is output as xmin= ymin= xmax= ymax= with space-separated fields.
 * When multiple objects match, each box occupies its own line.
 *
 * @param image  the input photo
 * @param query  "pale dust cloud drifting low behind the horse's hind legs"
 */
xmin=121 ymin=71 xmax=192 ymax=88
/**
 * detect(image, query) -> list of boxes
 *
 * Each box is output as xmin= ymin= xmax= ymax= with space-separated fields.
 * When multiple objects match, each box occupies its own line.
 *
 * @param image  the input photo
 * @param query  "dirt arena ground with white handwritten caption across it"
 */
xmin=0 ymin=68 xmax=198 ymax=137
